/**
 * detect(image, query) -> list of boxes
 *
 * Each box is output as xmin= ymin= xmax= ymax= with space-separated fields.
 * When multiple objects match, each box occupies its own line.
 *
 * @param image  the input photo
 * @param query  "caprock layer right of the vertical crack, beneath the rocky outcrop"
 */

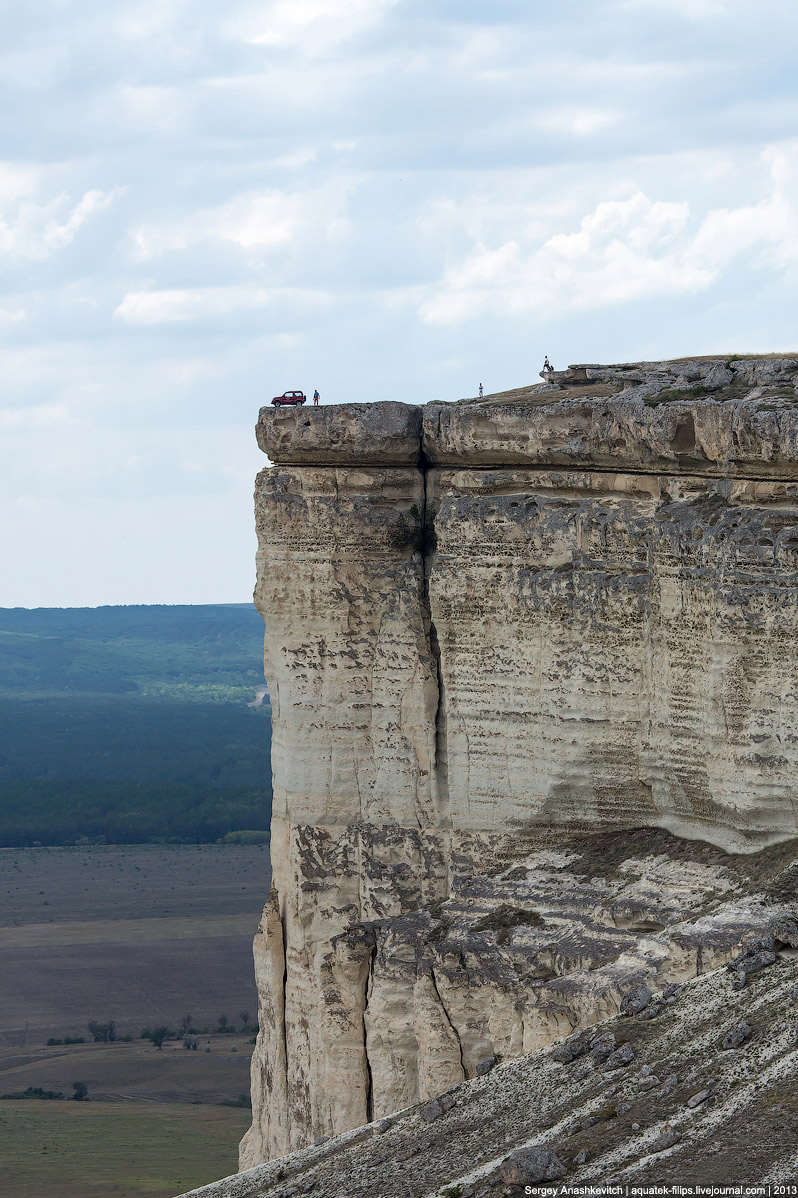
xmin=424 ymin=358 xmax=798 ymax=479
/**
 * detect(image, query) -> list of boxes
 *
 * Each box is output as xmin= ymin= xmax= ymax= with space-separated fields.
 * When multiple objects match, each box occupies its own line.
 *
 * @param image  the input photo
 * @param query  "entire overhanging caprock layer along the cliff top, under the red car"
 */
xmin=258 ymin=355 xmax=798 ymax=480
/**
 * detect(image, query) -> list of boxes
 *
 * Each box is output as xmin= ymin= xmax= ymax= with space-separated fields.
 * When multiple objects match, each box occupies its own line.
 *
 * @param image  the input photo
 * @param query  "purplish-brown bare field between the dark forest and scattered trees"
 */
xmin=0 ymin=845 xmax=270 ymax=1044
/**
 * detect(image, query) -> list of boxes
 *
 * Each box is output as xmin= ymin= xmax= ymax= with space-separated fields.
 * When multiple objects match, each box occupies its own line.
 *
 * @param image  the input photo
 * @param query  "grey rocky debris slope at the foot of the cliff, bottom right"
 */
xmin=179 ymin=876 xmax=798 ymax=1198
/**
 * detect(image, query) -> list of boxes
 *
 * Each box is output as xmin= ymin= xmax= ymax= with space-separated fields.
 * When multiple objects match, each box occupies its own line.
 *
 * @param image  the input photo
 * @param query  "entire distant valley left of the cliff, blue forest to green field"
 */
xmin=0 ymin=604 xmax=271 ymax=1198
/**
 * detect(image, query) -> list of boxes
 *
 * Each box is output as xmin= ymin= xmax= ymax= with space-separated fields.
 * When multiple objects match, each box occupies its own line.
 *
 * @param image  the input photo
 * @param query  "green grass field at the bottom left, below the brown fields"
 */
xmin=0 ymin=1097 xmax=249 ymax=1198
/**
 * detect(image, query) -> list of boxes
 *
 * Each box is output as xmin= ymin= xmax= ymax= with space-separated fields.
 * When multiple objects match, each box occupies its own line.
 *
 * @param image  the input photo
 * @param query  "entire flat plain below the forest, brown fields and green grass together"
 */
xmin=0 ymin=845 xmax=271 ymax=1198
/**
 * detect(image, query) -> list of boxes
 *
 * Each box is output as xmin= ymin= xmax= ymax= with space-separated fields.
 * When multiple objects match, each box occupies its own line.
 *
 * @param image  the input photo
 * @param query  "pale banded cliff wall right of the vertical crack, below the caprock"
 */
xmin=428 ymin=470 xmax=798 ymax=851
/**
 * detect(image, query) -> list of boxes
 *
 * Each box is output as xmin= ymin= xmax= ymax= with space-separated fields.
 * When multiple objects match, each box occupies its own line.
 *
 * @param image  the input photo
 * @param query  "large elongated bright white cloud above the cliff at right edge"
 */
xmin=419 ymin=153 xmax=798 ymax=325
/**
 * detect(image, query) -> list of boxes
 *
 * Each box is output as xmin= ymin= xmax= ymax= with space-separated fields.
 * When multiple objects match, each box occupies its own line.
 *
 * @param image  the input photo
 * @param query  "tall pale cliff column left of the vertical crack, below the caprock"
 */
xmin=242 ymin=462 xmax=447 ymax=1161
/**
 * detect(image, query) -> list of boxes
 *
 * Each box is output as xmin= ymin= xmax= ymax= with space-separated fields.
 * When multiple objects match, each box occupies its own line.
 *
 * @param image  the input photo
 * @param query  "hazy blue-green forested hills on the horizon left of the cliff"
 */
xmin=0 ymin=604 xmax=271 ymax=846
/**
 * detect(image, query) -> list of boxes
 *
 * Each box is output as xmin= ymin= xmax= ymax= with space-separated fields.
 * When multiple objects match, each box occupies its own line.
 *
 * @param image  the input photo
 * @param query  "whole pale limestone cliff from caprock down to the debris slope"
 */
xmin=241 ymin=359 xmax=798 ymax=1166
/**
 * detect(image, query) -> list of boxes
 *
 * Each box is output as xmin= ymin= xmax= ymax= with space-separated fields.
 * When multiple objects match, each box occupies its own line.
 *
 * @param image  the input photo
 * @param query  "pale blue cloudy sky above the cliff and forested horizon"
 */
xmin=0 ymin=0 xmax=798 ymax=606
